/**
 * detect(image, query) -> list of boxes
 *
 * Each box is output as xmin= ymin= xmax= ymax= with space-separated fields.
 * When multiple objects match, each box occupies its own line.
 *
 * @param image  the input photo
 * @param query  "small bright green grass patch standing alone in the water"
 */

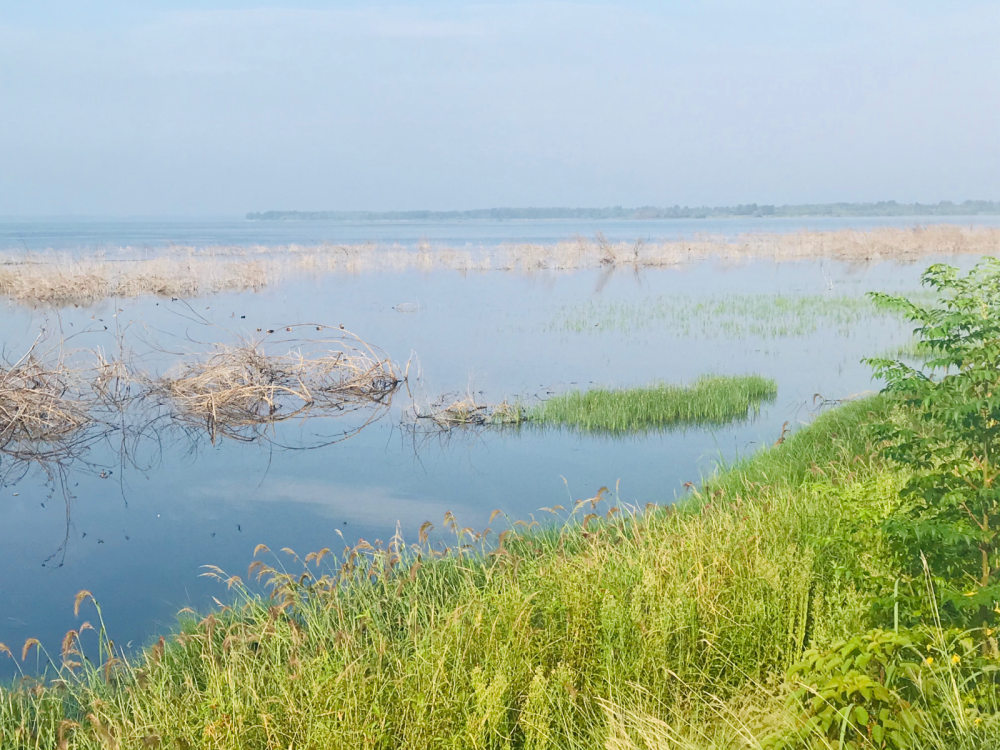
xmin=527 ymin=375 xmax=778 ymax=434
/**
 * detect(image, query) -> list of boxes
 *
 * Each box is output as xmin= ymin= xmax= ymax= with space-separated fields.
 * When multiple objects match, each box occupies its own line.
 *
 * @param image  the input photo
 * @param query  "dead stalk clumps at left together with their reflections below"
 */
xmin=0 ymin=325 xmax=405 ymax=568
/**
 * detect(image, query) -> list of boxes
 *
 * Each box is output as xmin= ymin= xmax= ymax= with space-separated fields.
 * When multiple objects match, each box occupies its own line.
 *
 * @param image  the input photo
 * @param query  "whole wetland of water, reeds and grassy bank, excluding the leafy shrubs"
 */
xmin=0 ymin=217 xmax=1000 ymax=748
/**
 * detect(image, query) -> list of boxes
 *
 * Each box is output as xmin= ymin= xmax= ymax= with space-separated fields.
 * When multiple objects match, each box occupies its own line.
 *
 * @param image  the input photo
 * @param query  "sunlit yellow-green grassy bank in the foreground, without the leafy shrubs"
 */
xmin=0 ymin=397 xmax=998 ymax=750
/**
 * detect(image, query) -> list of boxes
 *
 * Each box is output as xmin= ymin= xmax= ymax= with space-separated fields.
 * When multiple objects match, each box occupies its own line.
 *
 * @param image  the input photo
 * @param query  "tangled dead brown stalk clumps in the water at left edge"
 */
xmin=0 ymin=326 xmax=405 ymax=468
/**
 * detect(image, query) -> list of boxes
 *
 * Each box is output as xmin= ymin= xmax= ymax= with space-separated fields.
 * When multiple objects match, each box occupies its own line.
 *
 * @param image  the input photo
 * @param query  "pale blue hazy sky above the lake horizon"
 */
xmin=0 ymin=0 xmax=1000 ymax=215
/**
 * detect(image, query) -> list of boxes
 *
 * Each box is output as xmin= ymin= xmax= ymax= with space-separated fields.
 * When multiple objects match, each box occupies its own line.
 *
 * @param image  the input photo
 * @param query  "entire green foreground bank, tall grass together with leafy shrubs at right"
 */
xmin=9 ymin=262 xmax=1000 ymax=750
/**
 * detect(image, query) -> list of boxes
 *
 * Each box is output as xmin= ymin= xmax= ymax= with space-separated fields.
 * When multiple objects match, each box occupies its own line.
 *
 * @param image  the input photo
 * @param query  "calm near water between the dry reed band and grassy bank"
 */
xmin=0 ymin=220 xmax=980 ymax=674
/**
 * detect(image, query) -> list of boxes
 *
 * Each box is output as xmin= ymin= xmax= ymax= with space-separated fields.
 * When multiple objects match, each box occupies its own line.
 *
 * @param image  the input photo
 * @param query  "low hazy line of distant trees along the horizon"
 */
xmin=247 ymin=201 xmax=1000 ymax=221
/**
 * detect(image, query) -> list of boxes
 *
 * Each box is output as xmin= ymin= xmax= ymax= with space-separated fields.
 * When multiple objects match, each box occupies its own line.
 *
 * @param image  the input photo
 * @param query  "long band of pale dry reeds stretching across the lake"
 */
xmin=0 ymin=224 xmax=1000 ymax=305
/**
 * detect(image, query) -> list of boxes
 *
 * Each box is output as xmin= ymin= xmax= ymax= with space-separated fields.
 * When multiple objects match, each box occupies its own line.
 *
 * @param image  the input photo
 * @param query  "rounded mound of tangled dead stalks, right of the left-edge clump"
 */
xmin=153 ymin=331 xmax=403 ymax=442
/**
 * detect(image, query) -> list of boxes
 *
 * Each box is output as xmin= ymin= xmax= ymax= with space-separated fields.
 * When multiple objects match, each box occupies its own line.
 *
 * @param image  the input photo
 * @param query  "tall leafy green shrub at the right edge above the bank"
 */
xmin=869 ymin=259 xmax=1000 ymax=624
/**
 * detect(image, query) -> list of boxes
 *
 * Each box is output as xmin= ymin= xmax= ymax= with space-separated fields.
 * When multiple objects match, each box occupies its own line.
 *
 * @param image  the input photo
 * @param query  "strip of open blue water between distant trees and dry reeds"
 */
xmin=0 ymin=216 xmax=1000 ymax=252
